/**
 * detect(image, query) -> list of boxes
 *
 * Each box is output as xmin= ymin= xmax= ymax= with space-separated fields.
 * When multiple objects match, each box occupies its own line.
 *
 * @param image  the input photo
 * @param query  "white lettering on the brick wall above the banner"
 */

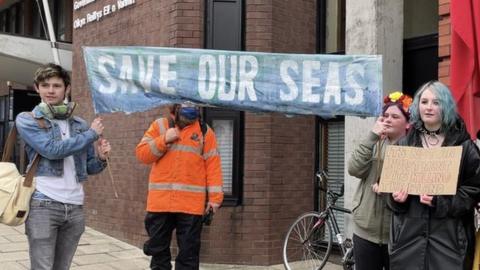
xmin=73 ymin=0 xmax=135 ymax=29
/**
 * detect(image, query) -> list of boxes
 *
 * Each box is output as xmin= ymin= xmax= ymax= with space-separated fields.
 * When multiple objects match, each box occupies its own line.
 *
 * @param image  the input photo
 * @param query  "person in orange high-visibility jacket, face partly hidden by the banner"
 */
xmin=136 ymin=104 xmax=223 ymax=270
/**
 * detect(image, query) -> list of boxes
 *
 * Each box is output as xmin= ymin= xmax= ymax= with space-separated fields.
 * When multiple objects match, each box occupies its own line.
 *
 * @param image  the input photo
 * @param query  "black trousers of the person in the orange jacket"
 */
xmin=143 ymin=212 xmax=202 ymax=270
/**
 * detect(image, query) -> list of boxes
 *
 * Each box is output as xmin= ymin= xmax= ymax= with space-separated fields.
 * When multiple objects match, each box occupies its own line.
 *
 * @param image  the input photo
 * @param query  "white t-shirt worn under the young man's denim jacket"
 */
xmin=35 ymin=120 xmax=85 ymax=205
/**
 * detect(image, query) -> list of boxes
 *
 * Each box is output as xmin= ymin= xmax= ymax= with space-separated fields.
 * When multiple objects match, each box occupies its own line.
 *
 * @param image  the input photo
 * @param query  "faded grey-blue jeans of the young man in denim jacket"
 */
xmin=25 ymin=199 xmax=85 ymax=270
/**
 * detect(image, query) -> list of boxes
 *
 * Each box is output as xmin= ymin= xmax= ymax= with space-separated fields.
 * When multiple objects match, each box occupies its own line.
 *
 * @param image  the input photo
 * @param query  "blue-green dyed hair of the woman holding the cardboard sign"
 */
xmin=410 ymin=81 xmax=458 ymax=132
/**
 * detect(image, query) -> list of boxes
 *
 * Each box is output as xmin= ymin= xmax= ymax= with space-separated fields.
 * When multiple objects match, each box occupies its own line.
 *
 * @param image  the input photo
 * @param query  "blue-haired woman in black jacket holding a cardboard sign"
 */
xmin=386 ymin=81 xmax=480 ymax=270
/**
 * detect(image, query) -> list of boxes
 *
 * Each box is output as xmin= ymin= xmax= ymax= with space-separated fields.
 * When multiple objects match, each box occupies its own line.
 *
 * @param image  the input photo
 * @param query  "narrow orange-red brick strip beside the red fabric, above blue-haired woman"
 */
xmin=438 ymin=0 xmax=451 ymax=85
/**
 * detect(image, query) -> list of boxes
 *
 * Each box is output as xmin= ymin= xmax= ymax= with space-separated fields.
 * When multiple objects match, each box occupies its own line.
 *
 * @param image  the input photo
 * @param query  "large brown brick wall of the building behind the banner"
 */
xmin=73 ymin=0 xmax=316 ymax=265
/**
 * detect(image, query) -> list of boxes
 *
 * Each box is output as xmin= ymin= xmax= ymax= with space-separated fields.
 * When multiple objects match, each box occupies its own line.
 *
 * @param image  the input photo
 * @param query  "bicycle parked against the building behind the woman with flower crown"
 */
xmin=283 ymin=171 xmax=354 ymax=270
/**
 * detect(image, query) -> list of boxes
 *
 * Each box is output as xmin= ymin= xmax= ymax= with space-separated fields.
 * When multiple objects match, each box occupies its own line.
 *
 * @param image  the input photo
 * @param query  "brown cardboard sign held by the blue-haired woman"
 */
xmin=379 ymin=145 xmax=462 ymax=195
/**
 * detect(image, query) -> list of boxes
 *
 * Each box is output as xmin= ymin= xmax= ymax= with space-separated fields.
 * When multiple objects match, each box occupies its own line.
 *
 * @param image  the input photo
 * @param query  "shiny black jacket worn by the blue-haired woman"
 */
xmin=387 ymin=120 xmax=480 ymax=270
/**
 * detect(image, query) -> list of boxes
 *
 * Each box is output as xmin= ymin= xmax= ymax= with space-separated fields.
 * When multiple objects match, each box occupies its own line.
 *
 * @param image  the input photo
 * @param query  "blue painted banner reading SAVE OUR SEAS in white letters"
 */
xmin=84 ymin=47 xmax=382 ymax=117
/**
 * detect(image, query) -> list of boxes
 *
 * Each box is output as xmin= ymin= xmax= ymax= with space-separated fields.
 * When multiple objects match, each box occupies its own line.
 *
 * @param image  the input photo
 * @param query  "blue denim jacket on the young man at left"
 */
xmin=15 ymin=106 xmax=106 ymax=182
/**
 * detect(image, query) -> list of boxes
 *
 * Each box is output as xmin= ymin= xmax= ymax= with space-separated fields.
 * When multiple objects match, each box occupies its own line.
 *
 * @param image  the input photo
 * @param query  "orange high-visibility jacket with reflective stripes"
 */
xmin=136 ymin=118 xmax=223 ymax=215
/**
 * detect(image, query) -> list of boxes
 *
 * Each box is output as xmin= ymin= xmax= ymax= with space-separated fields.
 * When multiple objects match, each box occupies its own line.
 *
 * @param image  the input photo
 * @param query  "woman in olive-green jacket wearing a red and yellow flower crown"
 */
xmin=348 ymin=91 xmax=412 ymax=270
